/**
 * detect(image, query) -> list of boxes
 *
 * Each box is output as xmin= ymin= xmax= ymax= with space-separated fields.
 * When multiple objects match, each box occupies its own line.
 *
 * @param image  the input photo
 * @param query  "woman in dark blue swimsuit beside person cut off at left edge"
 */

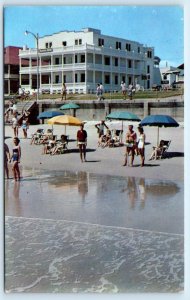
xmin=11 ymin=137 xmax=21 ymax=181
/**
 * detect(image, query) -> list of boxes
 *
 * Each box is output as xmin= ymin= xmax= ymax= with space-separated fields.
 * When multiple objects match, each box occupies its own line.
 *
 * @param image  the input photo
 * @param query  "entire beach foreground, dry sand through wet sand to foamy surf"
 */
xmin=4 ymin=121 xmax=184 ymax=295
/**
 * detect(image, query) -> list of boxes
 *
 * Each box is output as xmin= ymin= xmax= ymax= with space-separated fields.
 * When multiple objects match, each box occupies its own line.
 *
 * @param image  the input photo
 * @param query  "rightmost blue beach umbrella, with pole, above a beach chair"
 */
xmin=139 ymin=115 xmax=179 ymax=145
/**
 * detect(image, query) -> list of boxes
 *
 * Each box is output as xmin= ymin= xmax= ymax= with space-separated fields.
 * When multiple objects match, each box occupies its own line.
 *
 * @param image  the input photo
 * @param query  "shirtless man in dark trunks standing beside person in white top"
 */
xmin=123 ymin=125 xmax=137 ymax=167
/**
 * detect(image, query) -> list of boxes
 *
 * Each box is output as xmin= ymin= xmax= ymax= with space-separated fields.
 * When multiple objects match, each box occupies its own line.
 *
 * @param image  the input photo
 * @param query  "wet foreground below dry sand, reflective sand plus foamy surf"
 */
xmin=5 ymin=170 xmax=184 ymax=293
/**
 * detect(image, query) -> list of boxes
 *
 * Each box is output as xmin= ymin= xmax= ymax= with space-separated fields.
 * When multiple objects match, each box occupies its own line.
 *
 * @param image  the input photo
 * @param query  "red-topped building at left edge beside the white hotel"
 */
xmin=4 ymin=46 xmax=22 ymax=95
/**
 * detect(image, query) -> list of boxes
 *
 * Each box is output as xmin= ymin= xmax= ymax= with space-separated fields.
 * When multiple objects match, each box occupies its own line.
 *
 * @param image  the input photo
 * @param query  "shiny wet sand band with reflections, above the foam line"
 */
xmin=5 ymin=171 xmax=183 ymax=233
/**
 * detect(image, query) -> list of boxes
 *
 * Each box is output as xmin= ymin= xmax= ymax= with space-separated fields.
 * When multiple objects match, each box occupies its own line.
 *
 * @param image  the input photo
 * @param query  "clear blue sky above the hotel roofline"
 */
xmin=4 ymin=5 xmax=184 ymax=66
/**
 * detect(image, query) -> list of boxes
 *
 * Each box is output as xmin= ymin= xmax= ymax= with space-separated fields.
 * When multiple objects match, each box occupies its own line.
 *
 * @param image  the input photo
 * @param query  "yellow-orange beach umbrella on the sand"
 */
xmin=48 ymin=115 xmax=84 ymax=133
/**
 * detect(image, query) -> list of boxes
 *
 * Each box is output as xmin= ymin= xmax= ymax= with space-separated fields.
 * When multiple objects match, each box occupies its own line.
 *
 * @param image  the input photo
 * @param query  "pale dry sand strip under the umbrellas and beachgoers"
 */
xmin=5 ymin=121 xmax=184 ymax=181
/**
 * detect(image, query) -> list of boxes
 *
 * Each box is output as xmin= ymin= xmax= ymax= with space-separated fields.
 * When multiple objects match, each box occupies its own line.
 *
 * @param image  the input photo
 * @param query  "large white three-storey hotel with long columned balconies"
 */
xmin=19 ymin=28 xmax=154 ymax=93
